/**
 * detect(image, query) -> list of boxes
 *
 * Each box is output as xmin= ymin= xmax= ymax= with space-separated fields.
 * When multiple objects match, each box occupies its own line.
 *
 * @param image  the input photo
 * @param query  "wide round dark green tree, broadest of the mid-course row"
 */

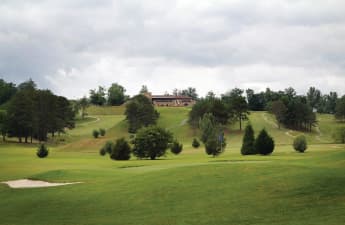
xmin=133 ymin=126 xmax=173 ymax=160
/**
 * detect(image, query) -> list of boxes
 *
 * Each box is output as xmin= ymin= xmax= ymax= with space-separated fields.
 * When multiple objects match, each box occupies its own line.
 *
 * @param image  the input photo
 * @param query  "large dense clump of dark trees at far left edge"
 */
xmin=0 ymin=80 xmax=76 ymax=143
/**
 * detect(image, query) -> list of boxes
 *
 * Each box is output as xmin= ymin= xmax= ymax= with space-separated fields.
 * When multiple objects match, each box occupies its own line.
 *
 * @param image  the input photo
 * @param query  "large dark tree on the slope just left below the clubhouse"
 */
xmin=125 ymin=95 xmax=159 ymax=133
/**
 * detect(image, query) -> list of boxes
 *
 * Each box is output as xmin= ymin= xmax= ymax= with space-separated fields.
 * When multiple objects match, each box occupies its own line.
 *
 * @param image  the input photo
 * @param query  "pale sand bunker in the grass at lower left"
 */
xmin=1 ymin=179 xmax=82 ymax=188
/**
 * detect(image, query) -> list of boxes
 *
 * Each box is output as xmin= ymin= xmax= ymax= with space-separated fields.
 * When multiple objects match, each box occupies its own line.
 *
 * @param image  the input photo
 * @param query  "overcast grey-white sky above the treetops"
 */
xmin=0 ymin=0 xmax=345 ymax=98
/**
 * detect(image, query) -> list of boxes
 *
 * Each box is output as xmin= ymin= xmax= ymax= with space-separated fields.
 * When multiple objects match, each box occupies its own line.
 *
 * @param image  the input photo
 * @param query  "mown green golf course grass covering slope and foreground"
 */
xmin=0 ymin=108 xmax=345 ymax=225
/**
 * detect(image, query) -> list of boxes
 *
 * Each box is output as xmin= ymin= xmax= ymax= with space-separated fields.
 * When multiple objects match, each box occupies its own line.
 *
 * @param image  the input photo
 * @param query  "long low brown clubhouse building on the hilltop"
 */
xmin=144 ymin=93 xmax=195 ymax=107
